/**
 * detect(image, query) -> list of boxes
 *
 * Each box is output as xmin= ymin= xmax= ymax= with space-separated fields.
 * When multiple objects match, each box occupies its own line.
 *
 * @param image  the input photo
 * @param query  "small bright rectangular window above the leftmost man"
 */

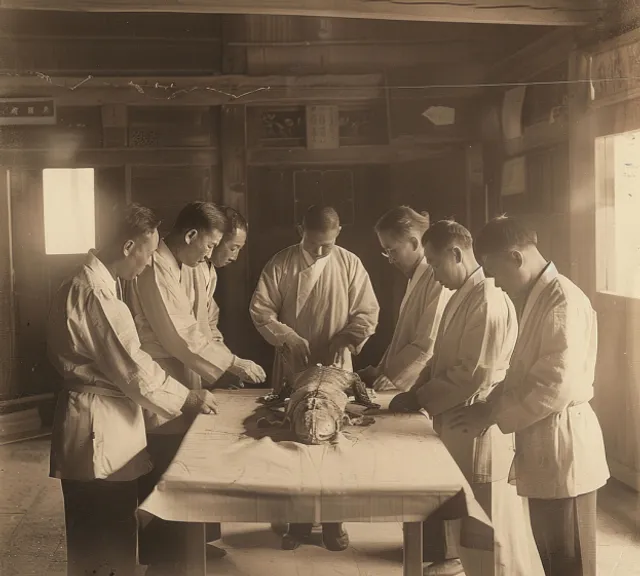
xmin=42 ymin=168 xmax=96 ymax=254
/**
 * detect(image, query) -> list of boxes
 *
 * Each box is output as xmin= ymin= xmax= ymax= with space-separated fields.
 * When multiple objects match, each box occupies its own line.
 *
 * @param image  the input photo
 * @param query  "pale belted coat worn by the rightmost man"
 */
xmin=490 ymin=263 xmax=609 ymax=499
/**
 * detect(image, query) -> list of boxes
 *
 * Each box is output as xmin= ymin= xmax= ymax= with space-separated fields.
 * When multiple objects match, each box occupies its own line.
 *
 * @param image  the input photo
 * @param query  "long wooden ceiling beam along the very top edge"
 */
xmin=0 ymin=0 xmax=603 ymax=26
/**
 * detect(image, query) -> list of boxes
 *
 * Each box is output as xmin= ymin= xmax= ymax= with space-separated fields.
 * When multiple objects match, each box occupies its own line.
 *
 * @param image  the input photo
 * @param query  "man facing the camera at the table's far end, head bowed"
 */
xmin=250 ymin=206 xmax=380 ymax=550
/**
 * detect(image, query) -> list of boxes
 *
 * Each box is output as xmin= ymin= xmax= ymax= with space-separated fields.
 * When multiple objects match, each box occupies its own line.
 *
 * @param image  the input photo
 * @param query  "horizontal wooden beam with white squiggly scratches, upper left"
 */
xmin=0 ymin=74 xmax=385 ymax=106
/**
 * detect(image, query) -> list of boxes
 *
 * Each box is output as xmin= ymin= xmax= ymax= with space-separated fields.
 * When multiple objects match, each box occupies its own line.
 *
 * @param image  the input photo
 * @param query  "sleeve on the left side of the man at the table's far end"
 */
xmin=249 ymin=255 xmax=295 ymax=348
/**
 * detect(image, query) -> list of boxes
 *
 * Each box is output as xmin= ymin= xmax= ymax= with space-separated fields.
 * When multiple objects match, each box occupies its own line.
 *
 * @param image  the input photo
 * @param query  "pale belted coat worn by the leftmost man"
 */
xmin=47 ymin=253 xmax=189 ymax=480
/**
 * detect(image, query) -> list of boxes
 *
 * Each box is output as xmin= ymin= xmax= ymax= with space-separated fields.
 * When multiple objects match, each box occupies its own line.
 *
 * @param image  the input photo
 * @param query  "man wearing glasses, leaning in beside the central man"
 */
xmin=359 ymin=206 xmax=451 ymax=391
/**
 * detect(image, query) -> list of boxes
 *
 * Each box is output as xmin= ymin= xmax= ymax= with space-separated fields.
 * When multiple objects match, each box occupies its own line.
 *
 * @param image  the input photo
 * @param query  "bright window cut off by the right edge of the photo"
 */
xmin=596 ymin=131 xmax=640 ymax=298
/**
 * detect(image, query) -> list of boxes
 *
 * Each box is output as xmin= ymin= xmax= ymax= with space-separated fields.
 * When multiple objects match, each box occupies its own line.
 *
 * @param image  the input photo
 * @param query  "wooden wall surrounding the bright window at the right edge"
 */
xmin=570 ymin=30 xmax=640 ymax=490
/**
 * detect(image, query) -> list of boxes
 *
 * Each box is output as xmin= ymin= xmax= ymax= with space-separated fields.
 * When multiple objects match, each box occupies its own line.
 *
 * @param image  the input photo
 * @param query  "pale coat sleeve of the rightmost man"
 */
xmin=492 ymin=302 xmax=598 ymax=434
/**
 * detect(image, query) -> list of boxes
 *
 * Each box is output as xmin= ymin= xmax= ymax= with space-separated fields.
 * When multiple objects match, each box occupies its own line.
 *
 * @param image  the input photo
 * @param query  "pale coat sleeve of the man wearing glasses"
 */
xmin=384 ymin=279 xmax=451 ymax=390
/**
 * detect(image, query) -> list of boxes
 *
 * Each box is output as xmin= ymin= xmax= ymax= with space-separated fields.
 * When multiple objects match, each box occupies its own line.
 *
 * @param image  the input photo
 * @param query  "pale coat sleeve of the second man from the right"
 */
xmin=417 ymin=299 xmax=515 ymax=416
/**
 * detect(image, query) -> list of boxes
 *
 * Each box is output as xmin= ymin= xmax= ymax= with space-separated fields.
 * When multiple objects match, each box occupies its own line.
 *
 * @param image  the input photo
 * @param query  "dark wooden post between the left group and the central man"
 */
xmin=217 ymin=106 xmax=254 ymax=358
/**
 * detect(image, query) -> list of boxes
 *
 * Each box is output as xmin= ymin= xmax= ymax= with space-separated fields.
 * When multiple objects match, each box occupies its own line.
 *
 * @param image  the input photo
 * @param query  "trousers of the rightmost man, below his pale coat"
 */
xmin=529 ymin=492 xmax=597 ymax=576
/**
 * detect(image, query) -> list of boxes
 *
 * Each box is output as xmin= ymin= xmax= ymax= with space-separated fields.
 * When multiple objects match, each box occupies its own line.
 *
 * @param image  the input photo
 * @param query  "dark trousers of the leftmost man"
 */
xmin=62 ymin=480 xmax=138 ymax=576
